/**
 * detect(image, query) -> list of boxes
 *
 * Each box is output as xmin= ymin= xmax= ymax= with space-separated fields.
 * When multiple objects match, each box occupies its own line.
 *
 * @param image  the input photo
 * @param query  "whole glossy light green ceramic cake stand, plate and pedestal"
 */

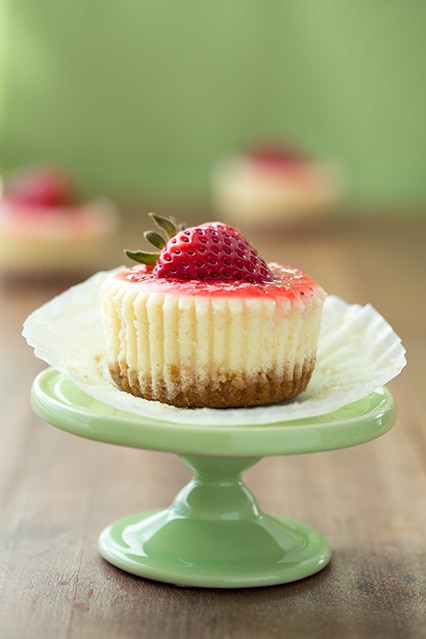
xmin=32 ymin=368 xmax=395 ymax=588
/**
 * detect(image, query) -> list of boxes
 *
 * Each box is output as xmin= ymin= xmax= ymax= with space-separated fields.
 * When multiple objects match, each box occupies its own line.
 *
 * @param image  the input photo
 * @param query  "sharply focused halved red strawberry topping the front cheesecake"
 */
xmin=153 ymin=222 xmax=273 ymax=284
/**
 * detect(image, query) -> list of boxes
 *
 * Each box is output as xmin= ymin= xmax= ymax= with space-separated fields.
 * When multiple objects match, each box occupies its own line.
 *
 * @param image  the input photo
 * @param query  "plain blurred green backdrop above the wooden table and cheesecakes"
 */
xmin=0 ymin=0 xmax=426 ymax=205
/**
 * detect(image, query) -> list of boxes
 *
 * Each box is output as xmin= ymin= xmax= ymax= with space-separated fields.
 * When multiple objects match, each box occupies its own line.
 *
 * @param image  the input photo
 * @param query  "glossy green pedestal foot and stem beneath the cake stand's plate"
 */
xmin=98 ymin=456 xmax=330 ymax=588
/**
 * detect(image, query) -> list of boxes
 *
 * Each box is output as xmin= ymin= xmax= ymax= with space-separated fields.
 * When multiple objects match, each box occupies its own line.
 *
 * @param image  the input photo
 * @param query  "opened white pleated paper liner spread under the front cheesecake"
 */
xmin=23 ymin=267 xmax=406 ymax=426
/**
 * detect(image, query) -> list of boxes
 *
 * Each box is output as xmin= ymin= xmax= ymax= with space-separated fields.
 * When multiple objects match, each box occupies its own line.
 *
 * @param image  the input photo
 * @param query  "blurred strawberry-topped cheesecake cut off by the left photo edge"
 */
xmin=0 ymin=166 xmax=119 ymax=277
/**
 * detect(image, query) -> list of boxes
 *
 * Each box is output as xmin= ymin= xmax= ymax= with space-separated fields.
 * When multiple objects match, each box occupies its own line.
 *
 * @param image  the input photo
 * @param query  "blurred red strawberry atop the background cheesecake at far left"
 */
xmin=6 ymin=168 xmax=71 ymax=207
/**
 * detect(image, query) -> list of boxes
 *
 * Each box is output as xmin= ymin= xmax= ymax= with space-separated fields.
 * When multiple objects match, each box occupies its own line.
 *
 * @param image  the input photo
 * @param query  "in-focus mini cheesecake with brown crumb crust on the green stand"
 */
xmin=100 ymin=216 xmax=325 ymax=408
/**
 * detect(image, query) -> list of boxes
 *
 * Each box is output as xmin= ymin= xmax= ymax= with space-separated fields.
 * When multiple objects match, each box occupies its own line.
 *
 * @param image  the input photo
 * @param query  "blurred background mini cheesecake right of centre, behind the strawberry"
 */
xmin=212 ymin=143 xmax=343 ymax=227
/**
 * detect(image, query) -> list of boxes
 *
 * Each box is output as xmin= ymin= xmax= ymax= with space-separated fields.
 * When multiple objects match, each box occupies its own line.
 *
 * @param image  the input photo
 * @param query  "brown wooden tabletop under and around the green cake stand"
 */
xmin=0 ymin=216 xmax=426 ymax=639
